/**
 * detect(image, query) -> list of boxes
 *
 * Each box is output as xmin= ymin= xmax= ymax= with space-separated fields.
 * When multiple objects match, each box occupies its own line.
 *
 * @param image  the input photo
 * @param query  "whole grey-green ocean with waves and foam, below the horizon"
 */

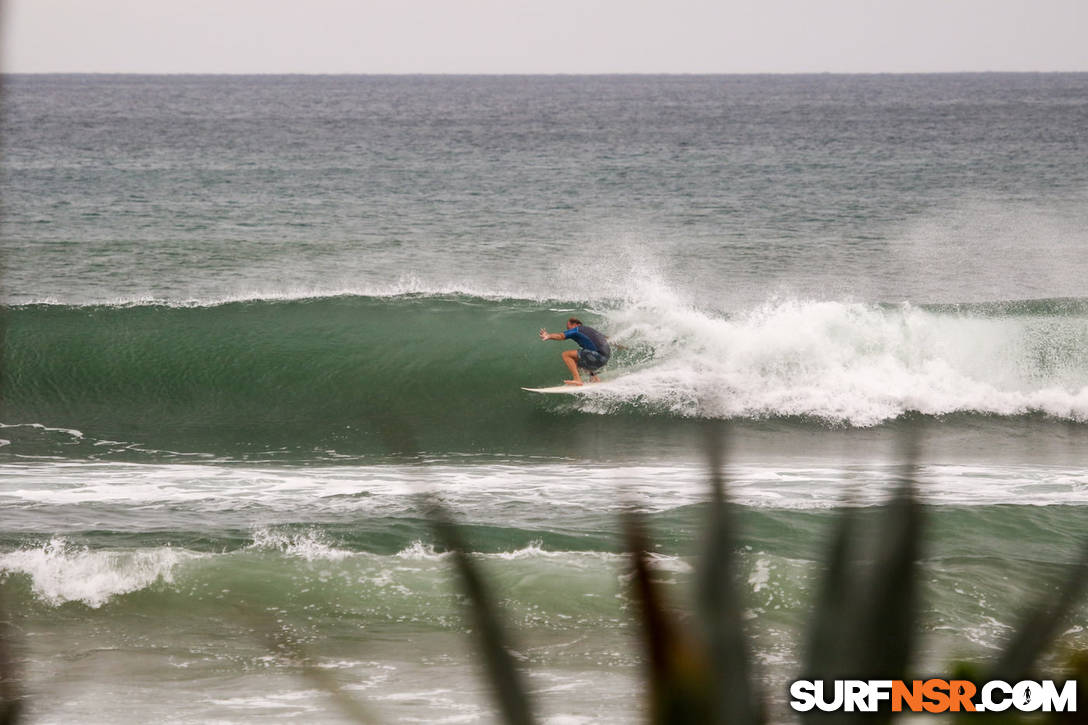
xmin=0 ymin=74 xmax=1088 ymax=723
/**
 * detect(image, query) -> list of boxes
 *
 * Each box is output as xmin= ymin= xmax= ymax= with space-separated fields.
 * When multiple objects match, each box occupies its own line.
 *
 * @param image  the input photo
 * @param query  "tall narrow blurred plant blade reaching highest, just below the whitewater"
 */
xmin=696 ymin=426 xmax=764 ymax=725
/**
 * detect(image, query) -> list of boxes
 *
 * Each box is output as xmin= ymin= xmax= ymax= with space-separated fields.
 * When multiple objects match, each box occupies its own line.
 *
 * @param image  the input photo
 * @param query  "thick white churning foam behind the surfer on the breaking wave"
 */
xmin=596 ymin=295 xmax=1088 ymax=427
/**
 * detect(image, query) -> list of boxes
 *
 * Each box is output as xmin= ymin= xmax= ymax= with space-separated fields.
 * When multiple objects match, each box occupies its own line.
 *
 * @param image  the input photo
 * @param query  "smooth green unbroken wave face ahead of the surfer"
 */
xmin=4 ymin=297 xmax=613 ymax=453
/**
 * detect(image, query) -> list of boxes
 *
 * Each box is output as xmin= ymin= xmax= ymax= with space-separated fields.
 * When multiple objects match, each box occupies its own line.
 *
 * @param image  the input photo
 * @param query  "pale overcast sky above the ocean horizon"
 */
xmin=0 ymin=0 xmax=1088 ymax=73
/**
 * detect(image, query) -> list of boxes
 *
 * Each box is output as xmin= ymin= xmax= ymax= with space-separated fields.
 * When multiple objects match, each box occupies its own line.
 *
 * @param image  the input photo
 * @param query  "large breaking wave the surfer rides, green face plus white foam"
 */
xmin=4 ymin=290 xmax=1088 ymax=453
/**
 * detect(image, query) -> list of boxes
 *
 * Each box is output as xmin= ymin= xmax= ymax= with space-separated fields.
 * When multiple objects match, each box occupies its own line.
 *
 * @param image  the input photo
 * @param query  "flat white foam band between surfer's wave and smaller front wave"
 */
xmin=0 ymin=462 xmax=1088 ymax=520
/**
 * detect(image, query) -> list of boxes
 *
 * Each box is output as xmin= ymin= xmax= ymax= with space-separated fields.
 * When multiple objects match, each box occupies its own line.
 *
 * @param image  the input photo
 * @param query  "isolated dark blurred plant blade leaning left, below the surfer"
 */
xmin=428 ymin=502 xmax=533 ymax=725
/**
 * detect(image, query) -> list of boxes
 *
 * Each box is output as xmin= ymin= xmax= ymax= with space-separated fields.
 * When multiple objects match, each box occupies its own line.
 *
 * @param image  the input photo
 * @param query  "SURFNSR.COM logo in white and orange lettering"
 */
xmin=790 ymin=679 xmax=1077 ymax=713
